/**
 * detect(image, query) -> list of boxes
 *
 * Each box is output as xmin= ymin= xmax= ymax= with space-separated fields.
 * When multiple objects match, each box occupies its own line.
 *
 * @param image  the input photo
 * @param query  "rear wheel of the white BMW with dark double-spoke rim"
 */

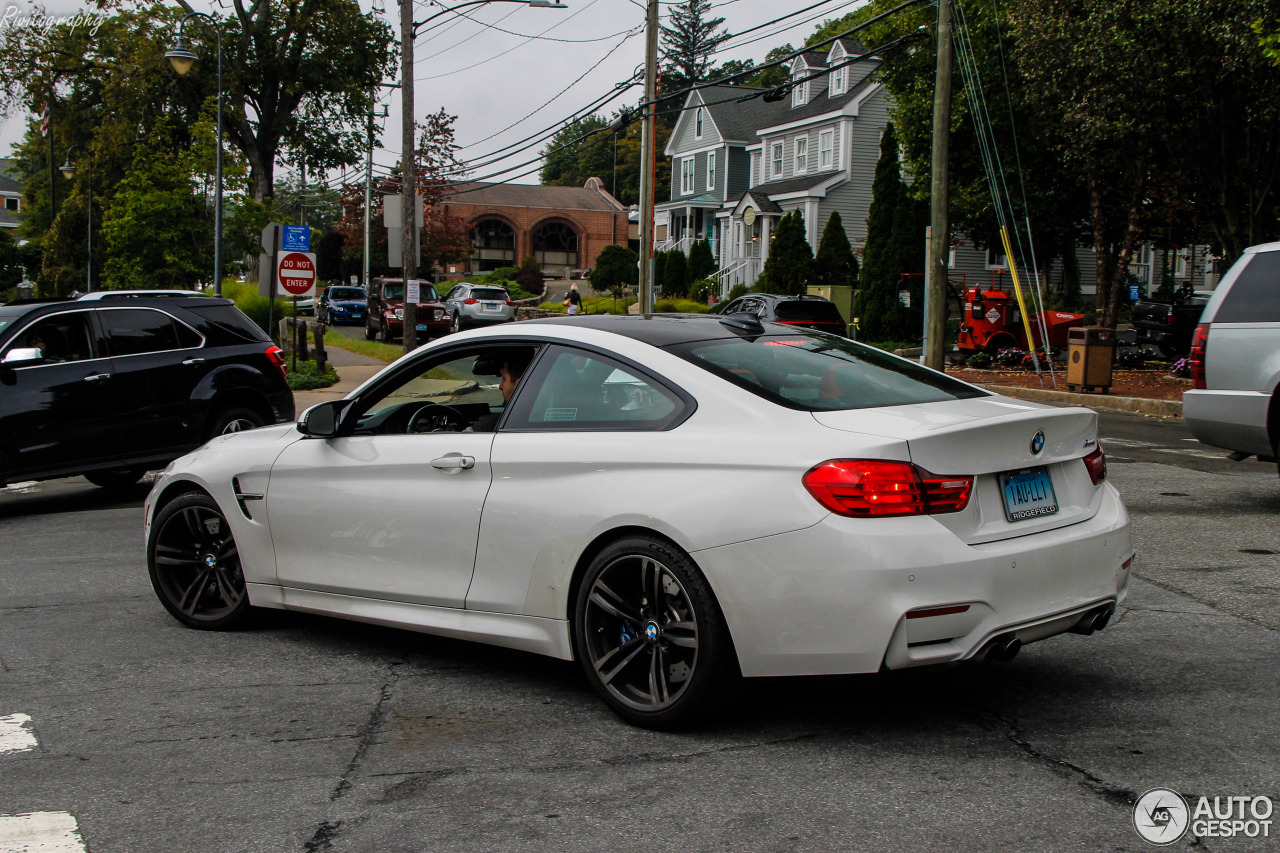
xmin=573 ymin=537 xmax=736 ymax=729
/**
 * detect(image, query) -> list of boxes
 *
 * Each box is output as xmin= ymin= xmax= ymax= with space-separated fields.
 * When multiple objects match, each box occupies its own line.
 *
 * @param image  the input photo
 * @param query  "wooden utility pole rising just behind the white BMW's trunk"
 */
xmin=924 ymin=0 xmax=951 ymax=370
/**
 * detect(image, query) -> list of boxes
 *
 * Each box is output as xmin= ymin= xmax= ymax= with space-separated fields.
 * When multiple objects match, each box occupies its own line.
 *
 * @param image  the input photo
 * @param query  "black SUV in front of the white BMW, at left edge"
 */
xmin=0 ymin=291 xmax=293 ymax=487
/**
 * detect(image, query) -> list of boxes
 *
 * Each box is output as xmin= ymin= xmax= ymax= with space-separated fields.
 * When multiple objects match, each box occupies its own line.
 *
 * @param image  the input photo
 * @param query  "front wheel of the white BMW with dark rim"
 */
xmin=147 ymin=492 xmax=250 ymax=630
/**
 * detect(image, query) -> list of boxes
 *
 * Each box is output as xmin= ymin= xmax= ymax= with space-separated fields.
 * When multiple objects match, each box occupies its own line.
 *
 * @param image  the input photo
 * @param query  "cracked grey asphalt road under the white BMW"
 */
xmin=0 ymin=415 xmax=1280 ymax=853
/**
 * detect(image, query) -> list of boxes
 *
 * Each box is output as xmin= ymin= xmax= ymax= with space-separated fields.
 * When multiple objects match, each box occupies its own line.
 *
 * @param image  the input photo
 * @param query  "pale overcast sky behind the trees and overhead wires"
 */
xmin=0 ymin=0 xmax=865 ymax=183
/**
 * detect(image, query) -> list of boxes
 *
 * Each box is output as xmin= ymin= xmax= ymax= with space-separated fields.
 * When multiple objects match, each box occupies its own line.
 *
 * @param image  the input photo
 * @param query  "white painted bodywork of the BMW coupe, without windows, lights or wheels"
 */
xmin=147 ymin=324 xmax=1133 ymax=675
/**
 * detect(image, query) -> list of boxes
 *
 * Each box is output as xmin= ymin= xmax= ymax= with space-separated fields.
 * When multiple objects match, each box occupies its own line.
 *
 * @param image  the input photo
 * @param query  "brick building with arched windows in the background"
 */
xmin=444 ymin=178 xmax=627 ymax=277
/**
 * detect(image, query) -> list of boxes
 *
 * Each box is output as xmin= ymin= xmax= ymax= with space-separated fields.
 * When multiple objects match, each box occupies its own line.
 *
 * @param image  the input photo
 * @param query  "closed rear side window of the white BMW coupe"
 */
xmin=504 ymin=347 xmax=686 ymax=430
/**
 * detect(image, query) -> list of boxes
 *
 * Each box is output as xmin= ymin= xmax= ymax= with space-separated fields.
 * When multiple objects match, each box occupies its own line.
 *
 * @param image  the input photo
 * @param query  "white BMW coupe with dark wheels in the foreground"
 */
xmin=146 ymin=314 xmax=1134 ymax=727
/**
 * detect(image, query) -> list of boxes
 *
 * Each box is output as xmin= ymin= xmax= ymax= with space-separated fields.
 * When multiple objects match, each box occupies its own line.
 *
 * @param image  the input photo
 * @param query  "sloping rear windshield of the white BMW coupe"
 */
xmin=671 ymin=334 xmax=989 ymax=411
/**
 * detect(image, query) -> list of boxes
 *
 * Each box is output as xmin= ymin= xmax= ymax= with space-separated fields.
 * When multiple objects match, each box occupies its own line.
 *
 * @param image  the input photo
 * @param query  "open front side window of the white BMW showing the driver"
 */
xmin=344 ymin=346 xmax=536 ymax=435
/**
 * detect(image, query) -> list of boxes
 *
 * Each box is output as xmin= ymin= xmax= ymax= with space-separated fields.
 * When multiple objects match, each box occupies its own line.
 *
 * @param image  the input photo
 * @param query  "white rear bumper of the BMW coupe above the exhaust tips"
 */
xmin=692 ymin=485 xmax=1134 ymax=676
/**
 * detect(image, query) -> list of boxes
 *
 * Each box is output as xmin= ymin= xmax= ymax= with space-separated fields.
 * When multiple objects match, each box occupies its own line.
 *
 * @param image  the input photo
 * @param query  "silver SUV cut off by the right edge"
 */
xmin=1183 ymin=243 xmax=1280 ymax=462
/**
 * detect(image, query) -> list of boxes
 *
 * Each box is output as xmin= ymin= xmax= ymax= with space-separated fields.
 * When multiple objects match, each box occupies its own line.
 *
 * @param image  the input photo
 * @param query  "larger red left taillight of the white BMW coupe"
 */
xmin=804 ymin=459 xmax=973 ymax=519
